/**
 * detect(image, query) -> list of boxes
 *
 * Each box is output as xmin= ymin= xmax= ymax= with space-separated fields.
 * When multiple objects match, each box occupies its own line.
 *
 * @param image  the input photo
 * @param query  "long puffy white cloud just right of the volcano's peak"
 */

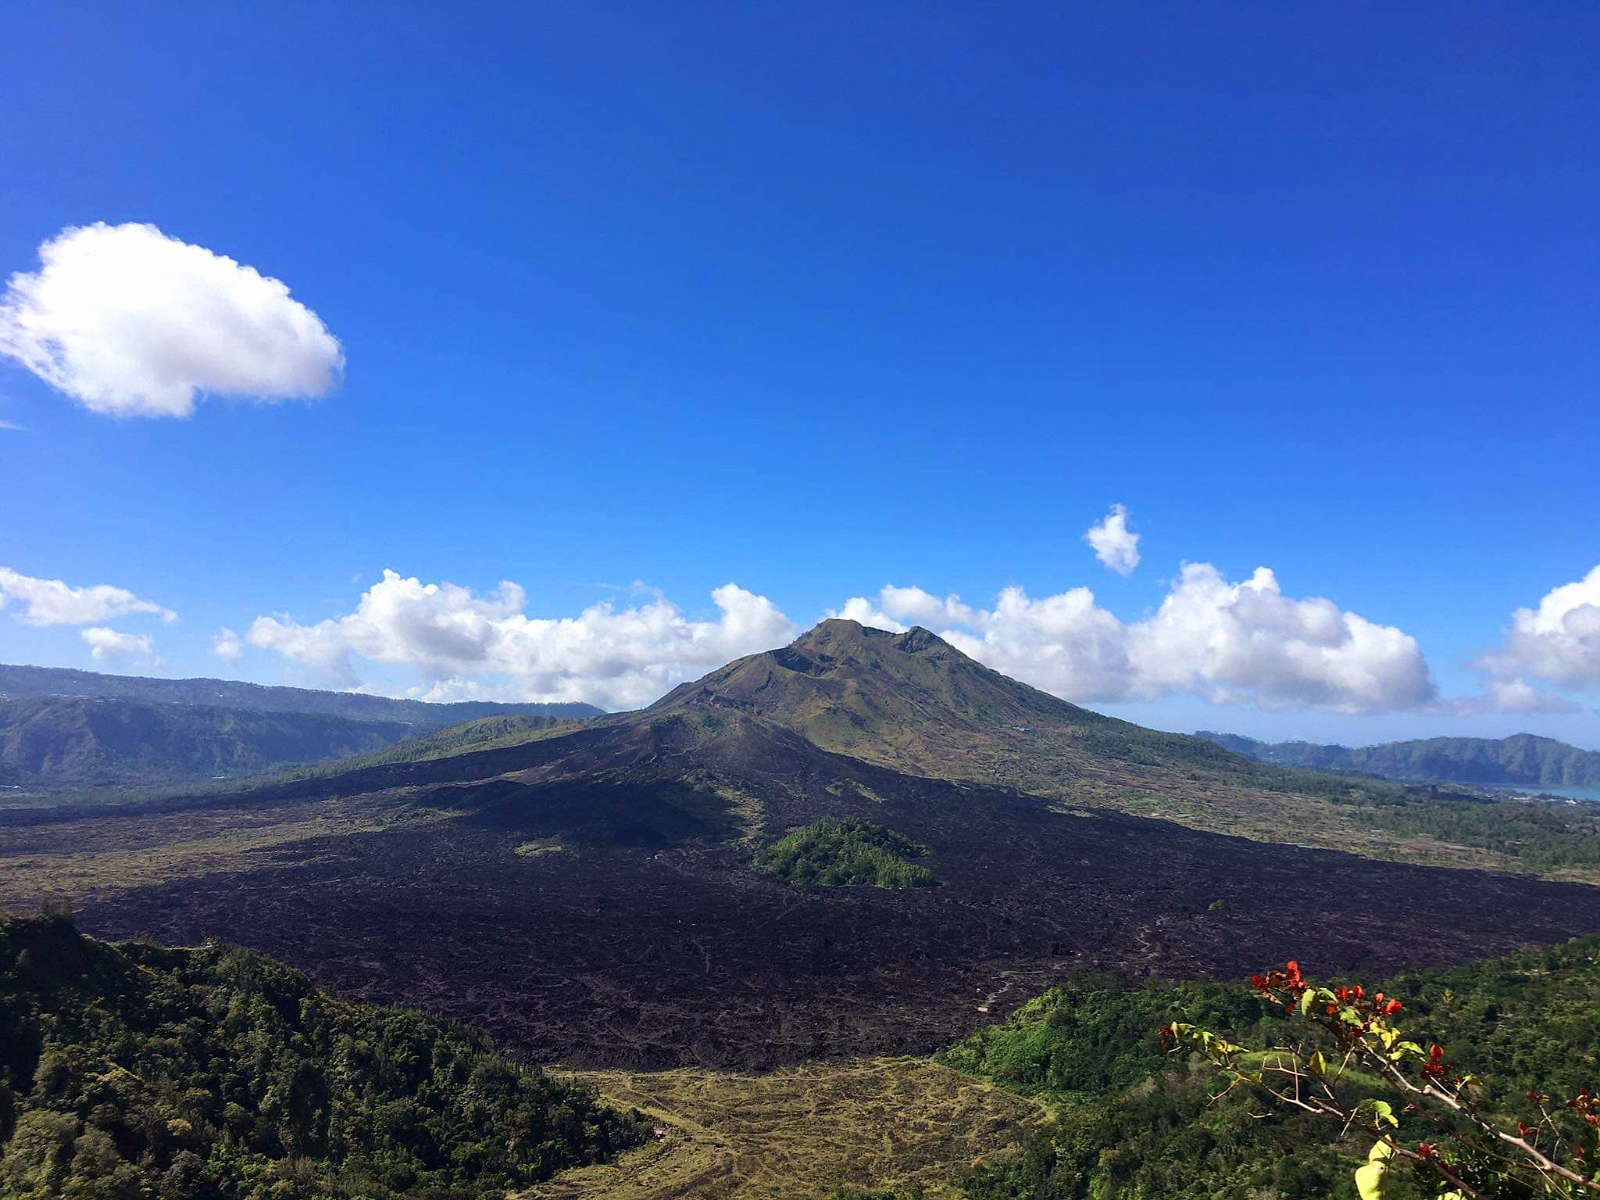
xmin=838 ymin=563 xmax=1435 ymax=712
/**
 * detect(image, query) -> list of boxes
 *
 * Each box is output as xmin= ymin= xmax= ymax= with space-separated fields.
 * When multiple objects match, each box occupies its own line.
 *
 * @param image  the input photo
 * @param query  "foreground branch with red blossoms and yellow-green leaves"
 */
xmin=1162 ymin=962 xmax=1600 ymax=1200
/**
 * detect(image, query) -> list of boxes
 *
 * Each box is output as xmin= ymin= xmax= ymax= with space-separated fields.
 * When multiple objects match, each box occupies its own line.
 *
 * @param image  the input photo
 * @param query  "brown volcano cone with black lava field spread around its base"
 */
xmin=21 ymin=622 xmax=1600 ymax=1066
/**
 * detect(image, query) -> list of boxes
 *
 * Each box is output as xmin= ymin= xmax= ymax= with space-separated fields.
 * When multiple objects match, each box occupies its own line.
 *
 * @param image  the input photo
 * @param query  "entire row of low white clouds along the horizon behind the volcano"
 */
xmin=0 ymin=563 xmax=1600 ymax=715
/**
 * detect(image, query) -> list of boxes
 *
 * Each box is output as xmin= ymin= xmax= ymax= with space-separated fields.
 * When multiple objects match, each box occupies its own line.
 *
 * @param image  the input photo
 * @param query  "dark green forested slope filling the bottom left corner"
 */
xmin=0 ymin=915 xmax=648 ymax=1200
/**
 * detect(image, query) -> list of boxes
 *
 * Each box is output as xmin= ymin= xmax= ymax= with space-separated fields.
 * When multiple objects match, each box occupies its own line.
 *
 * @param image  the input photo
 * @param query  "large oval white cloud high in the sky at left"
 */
xmin=0 ymin=224 xmax=344 ymax=416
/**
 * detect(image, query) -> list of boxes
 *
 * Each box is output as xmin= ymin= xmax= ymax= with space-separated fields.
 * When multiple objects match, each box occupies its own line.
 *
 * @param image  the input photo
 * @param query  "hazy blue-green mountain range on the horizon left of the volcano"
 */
xmin=0 ymin=666 xmax=600 ymax=787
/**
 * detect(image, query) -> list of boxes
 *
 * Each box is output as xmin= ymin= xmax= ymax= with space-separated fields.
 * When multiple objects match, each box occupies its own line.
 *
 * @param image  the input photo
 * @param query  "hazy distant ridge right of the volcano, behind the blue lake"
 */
xmin=1197 ymin=731 xmax=1600 ymax=787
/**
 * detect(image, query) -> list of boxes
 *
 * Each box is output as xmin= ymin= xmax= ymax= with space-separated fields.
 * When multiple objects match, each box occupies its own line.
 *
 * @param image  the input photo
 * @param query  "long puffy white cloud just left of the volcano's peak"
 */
xmin=245 ymin=571 xmax=797 ymax=709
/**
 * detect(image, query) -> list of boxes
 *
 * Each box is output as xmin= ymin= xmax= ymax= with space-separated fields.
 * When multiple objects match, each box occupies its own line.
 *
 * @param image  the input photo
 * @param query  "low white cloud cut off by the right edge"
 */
xmin=1478 ymin=566 xmax=1600 ymax=700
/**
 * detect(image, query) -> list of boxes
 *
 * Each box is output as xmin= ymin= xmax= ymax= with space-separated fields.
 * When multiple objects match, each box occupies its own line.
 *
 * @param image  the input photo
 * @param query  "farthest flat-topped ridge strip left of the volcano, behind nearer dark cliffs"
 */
xmin=0 ymin=666 xmax=600 ymax=733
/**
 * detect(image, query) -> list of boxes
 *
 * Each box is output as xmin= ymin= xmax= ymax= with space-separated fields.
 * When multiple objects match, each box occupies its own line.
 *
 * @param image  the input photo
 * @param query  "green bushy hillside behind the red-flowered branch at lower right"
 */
xmin=939 ymin=938 xmax=1600 ymax=1200
